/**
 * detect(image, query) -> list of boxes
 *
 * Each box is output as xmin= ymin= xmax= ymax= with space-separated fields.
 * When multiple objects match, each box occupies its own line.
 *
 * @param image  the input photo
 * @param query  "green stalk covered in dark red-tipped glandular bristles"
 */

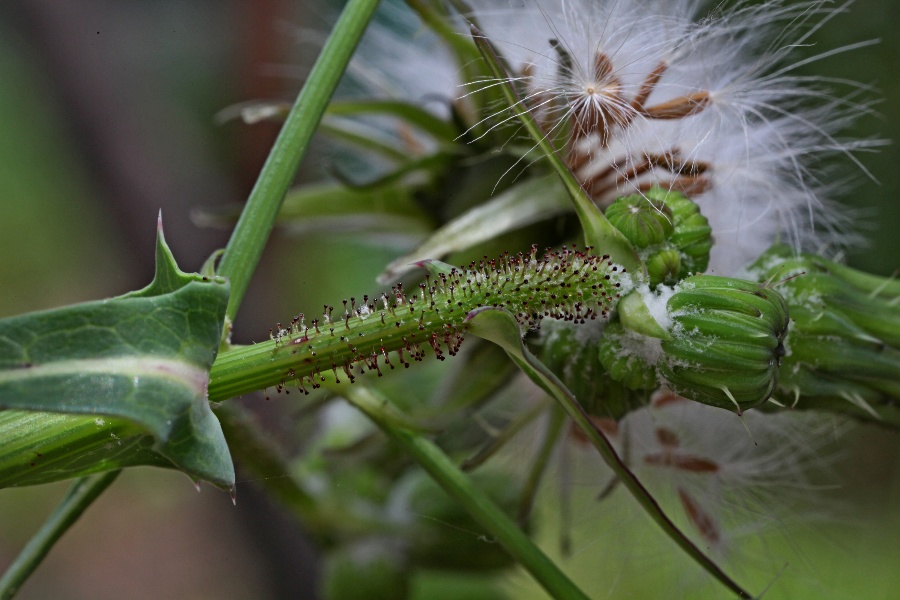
xmin=210 ymin=248 xmax=631 ymax=400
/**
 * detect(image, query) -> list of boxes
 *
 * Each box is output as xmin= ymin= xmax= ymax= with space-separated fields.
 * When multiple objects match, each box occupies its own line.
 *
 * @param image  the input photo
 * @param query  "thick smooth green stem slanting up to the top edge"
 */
xmin=219 ymin=0 xmax=378 ymax=324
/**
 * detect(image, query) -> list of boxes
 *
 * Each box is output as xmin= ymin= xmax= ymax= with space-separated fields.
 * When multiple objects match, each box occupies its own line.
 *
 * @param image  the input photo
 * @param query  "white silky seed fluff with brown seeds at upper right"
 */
xmin=470 ymin=0 xmax=878 ymax=275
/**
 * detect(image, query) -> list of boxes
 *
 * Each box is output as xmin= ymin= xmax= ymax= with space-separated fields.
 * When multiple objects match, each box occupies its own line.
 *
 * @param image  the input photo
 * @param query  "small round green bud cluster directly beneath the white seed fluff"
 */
xmin=606 ymin=187 xmax=712 ymax=287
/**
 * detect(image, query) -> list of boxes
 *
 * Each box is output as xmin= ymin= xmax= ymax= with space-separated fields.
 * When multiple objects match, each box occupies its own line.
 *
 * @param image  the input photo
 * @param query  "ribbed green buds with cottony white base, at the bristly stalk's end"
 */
xmin=599 ymin=275 xmax=788 ymax=413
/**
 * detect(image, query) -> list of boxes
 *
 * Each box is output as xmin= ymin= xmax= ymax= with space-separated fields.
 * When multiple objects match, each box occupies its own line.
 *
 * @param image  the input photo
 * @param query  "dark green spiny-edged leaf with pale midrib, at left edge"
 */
xmin=0 ymin=220 xmax=234 ymax=486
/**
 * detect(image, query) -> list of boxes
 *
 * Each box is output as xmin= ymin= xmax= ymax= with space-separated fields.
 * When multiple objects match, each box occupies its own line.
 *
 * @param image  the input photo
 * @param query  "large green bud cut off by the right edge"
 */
xmin=753 ymin=246 xmax=900 ymax=426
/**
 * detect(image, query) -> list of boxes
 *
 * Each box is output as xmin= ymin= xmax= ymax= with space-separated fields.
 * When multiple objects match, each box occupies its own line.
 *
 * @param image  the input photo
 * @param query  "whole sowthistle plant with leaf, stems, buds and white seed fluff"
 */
xmin=0 ymin=0 xmax=900 ymax=600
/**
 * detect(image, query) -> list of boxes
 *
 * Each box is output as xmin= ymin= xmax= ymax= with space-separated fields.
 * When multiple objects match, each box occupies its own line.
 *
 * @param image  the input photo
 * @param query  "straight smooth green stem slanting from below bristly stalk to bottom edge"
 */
xmin=341 ymin=384 xmax=587 ymax=600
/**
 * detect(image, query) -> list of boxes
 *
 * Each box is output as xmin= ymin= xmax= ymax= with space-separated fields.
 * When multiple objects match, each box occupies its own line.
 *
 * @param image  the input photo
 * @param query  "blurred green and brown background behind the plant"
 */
xmin=0 ymin=0 xmax=900 ymax=599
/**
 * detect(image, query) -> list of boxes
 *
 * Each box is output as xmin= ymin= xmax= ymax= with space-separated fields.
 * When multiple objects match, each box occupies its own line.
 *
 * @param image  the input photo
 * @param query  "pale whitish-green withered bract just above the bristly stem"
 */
xmin=378 ymin=176 xmax=571 ymax=285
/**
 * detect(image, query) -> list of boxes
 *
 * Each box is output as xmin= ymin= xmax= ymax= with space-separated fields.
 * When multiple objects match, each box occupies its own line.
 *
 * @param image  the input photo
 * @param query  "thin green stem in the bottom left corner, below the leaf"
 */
xmin=0 ymin=471 xmax=121 ymax=600
